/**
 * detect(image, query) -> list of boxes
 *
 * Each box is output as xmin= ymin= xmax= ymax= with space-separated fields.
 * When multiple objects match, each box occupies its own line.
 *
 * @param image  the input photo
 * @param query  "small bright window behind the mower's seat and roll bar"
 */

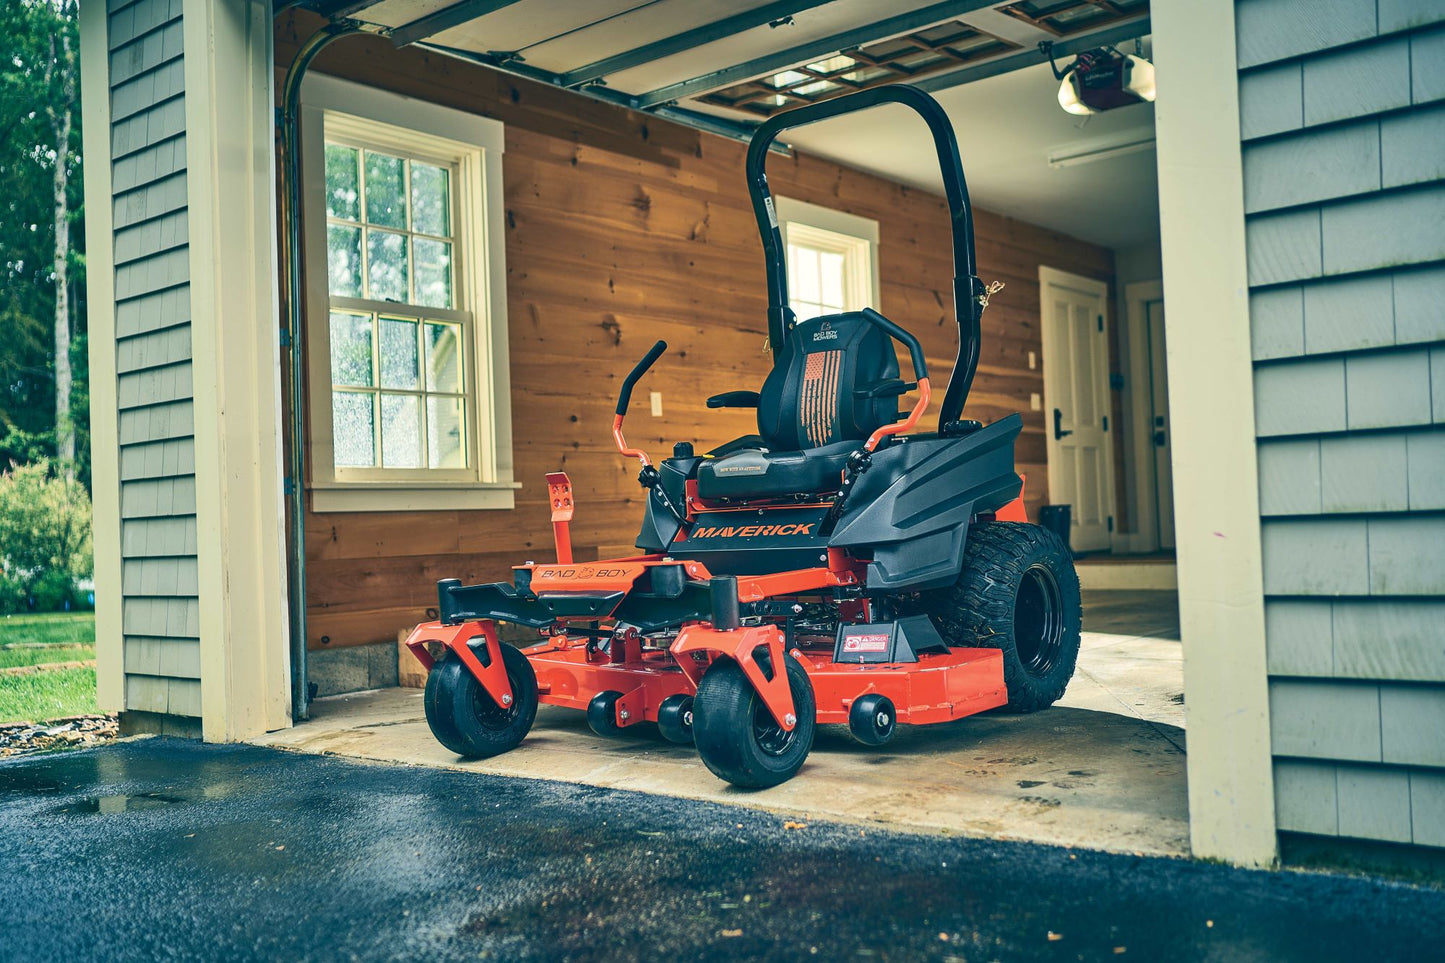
xmin=777 ymin=198 xmax=879 ymax=321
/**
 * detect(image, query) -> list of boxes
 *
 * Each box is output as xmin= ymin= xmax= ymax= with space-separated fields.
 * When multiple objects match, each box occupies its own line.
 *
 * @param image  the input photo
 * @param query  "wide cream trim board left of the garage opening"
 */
xmin=184 ymin=0 xmax=290 ymax=742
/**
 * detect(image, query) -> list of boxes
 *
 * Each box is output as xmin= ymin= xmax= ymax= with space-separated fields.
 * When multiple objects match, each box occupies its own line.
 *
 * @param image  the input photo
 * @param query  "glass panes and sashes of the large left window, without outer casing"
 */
xmin=327 ymin=140 xmax=471 ymax=468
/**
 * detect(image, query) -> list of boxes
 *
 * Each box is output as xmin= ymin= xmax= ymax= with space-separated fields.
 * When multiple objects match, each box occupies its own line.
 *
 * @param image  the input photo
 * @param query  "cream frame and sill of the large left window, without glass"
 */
xmin=301 ymin=74 xmax=522 ymax=512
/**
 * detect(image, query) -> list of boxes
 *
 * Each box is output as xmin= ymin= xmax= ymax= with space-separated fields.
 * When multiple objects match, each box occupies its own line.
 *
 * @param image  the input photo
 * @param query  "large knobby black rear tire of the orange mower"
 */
xmin=909 ymin=522 xmax=1084 ymax=713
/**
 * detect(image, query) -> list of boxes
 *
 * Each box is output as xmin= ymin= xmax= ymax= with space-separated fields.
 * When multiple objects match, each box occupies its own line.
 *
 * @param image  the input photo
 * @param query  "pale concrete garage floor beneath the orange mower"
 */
xmin=256 ymin=591 xmax=1189 ymax=856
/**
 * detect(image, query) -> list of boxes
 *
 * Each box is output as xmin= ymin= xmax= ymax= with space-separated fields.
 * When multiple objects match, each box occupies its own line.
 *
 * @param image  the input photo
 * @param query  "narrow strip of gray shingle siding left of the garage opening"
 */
xmin=108 ymin=0 xmax=201 ymax=705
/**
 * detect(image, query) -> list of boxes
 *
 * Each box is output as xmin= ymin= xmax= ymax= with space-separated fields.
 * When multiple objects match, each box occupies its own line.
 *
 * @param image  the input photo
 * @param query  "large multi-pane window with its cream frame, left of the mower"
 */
xmin=302 ymin=75 xmax=516 ymax=512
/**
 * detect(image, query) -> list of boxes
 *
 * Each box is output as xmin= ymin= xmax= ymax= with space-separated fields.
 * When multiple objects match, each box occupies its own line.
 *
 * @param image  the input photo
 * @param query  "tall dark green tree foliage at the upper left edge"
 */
xmin=0 ymin=0 xmax=90 ymax=486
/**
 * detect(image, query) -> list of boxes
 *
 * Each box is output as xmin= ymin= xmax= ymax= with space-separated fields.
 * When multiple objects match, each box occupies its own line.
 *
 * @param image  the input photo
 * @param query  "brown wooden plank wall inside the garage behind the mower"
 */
xmin=276 ymin=14 xmax=1113 ymax=648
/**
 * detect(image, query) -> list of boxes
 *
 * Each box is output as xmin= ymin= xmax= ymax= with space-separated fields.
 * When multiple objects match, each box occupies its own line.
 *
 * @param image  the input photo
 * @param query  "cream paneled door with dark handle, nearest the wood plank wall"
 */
xmin=1039 ymin=268 xmax=1114 ymax=552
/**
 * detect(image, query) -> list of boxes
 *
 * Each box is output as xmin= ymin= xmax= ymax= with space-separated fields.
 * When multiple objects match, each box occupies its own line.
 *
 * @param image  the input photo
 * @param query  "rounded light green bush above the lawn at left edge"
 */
xmin=0 ymin=461 xmax=92 ymax=612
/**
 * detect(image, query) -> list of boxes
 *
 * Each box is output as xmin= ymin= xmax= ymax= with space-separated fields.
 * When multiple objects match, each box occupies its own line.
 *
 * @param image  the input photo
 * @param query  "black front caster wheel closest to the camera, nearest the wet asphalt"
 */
xmin=692 ymin=655 xmax=816 ymax=789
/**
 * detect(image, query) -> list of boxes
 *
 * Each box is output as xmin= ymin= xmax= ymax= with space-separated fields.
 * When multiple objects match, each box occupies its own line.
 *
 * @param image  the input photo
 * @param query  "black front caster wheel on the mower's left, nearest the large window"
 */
xmin=442 ymin=645 xmax=538 ymax=759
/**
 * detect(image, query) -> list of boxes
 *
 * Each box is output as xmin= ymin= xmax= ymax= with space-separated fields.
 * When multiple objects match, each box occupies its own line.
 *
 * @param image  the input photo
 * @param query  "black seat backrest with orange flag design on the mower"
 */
xmin=757 ymin=314 xmax=899 ymax=451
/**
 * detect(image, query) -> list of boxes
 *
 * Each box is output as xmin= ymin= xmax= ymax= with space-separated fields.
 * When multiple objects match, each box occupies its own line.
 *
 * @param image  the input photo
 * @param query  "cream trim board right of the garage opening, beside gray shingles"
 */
xmin=1150 ymin=3 xmax=1277 ymax=866
